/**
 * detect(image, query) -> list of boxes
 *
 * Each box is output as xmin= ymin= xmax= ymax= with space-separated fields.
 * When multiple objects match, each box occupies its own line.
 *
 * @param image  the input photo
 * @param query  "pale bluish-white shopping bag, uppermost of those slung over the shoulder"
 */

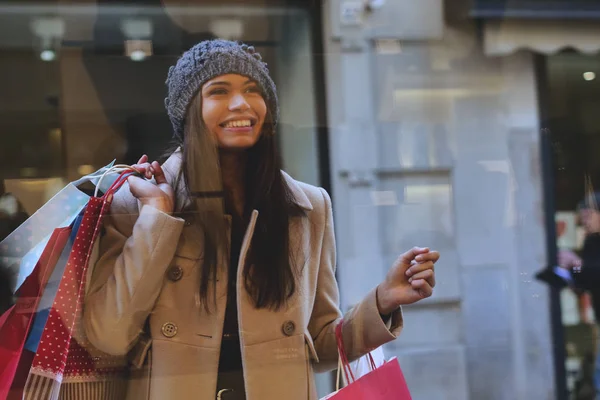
xmin=0 ymin=161 xmax=119 ymax=291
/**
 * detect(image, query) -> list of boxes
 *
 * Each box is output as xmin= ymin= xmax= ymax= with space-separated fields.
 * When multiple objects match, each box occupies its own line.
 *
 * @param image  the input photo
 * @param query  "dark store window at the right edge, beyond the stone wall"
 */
xmin=542 ymin=51 xmax=600 ymax=398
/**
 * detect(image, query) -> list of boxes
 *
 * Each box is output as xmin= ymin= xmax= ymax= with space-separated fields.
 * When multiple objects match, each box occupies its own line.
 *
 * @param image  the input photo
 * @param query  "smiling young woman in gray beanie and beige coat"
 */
xmin=84 ymin=40 xmax=439 ymax=400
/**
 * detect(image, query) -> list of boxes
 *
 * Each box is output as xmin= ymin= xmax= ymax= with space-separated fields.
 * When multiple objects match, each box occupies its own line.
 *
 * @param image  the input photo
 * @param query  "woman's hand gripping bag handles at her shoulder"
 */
xmin=127 ymin=154 xmax=175 ymax=214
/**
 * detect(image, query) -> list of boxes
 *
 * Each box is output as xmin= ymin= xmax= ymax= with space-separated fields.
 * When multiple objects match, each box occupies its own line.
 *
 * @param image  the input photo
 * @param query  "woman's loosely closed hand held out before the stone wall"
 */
xmin=377 ymin=247 xmax=440 ymax=315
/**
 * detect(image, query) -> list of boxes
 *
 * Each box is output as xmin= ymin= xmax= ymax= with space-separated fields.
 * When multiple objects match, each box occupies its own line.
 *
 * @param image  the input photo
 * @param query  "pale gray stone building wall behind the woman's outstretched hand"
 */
xmin=324 ymin=1 xmax=553 ymax=400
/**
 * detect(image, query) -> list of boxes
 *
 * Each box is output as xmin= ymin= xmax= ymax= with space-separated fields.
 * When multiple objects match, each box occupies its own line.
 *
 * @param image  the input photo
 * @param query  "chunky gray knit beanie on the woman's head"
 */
xmin=165 ymin=39 xmax=279 ymax=139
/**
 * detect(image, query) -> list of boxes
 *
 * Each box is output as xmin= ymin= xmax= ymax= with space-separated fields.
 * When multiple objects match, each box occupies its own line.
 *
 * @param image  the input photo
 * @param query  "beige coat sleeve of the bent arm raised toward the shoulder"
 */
xmin=83 ymin=185 xmax=184 ymax=355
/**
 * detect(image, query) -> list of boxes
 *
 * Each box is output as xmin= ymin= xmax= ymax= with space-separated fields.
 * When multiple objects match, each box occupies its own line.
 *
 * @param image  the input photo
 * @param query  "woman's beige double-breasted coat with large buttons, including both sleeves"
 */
xmin=84 ymin=153 xmax=402 ymax=400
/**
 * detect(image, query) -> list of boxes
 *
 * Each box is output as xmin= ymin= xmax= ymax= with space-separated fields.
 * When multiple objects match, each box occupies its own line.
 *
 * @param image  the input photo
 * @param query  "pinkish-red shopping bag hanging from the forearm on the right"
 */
xmin=322 ymin=321 xmax=411 ymax=400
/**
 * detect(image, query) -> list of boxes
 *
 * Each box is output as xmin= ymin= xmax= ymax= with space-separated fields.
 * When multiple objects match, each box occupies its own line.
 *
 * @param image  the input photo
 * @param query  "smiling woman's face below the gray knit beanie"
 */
xmin=201 ymin=74 xmax=267 ymax=150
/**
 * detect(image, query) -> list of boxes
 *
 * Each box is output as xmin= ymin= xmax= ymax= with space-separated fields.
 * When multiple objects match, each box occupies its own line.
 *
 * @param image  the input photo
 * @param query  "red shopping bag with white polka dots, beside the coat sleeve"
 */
xmin=25 ymin=172 xmax=138 ymax=400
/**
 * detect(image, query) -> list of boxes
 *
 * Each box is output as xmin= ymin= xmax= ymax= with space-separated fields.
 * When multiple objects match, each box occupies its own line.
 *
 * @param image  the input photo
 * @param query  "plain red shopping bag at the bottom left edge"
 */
xmin=0 ymin=227 xmax=71 ymax=399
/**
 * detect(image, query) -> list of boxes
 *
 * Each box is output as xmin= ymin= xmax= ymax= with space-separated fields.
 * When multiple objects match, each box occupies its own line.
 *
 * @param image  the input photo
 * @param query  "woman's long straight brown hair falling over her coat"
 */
xmin=168 ymin=95 xmax=304 ymax=311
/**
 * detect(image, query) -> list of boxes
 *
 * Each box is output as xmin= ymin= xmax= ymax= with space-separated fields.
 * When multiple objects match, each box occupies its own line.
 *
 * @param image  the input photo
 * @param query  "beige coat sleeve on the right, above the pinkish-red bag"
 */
xmin=308 ymin=189 xmax=403 ymax=371
